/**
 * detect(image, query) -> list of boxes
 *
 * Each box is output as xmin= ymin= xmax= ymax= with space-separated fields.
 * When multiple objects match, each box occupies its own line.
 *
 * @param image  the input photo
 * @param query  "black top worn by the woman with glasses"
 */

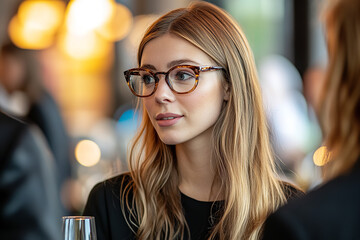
xmin=83 ymin=174 xmax=301 ymax=240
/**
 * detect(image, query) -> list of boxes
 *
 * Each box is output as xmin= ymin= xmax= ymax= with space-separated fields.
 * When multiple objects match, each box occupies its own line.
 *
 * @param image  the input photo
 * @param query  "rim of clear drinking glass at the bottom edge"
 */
xmin=62 ymin=216 xmax=96 ymax=240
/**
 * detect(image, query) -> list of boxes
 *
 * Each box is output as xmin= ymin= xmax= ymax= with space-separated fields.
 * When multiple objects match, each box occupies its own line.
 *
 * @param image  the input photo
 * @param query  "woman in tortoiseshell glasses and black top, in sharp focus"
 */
xmin=84 ymin=2 xmax=298 ymax=240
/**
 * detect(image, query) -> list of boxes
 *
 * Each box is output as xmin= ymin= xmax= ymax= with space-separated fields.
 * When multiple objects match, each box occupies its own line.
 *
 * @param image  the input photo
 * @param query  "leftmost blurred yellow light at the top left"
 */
xmin=8 ymin=0 xmax=65 ymax=49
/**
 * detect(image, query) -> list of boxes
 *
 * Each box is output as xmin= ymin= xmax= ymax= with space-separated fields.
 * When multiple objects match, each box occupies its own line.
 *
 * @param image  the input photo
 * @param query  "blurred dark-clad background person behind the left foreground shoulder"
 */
xmin=0 ymin=42 xmax=71 ymax=215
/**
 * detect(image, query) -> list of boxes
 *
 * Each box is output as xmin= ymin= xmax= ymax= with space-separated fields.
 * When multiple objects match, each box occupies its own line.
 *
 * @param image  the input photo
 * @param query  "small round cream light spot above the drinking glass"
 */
xmin=75 ymin=140 xmax=101 ymax=167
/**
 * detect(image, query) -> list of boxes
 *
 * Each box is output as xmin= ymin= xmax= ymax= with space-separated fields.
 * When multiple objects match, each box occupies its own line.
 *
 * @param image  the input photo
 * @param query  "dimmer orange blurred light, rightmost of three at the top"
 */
xmin=97 ymin=2 xmax=133 ymax=41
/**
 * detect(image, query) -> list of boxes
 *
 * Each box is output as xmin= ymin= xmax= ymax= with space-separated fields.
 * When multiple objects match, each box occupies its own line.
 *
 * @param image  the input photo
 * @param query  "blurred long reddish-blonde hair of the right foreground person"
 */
xmin=320 ymin=0 xmax=360 ymax=179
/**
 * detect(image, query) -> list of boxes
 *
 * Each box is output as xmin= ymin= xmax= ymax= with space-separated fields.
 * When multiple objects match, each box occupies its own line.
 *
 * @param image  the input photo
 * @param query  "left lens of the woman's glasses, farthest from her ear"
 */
xmin=128 ymin=70 xmax=155 ymax=96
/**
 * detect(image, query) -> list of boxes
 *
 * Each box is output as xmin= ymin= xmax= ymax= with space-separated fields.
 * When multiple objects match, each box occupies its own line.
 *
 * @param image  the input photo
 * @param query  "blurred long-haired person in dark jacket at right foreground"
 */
xmin=264 ymin=0 xmax=360 ymax=240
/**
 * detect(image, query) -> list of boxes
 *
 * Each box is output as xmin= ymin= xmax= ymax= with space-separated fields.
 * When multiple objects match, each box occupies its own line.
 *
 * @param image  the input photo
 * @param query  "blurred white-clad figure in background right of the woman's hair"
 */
xmin=259 ymin=55 xmax=320 ymax=179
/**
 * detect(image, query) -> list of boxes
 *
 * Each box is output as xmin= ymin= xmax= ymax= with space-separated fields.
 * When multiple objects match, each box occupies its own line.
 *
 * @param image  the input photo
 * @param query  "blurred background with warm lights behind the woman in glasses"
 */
xmin=0 ymin=0 xmax=327 ymax=214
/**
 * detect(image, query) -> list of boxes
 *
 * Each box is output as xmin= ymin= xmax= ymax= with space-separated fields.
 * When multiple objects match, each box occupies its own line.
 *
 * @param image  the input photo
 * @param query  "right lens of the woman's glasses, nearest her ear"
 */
xmin=169 ymin=67 xmax=196 ymax=93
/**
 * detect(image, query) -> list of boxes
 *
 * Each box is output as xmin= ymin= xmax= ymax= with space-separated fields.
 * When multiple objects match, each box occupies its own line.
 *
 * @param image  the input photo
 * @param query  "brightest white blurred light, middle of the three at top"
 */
xmin=66 ymin=0 xmax=113 ymax=35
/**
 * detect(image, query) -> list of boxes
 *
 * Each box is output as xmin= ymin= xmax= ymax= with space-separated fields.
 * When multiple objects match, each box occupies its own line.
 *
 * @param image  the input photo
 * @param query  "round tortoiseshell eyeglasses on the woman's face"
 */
xmin=124 ymin=65 xmax=223 ymax=97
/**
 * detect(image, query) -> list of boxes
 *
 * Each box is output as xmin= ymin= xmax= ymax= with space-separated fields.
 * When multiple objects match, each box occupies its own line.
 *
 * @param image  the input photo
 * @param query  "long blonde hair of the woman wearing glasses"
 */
xmin=122 ymin=2 xmax=286 ymax=240
